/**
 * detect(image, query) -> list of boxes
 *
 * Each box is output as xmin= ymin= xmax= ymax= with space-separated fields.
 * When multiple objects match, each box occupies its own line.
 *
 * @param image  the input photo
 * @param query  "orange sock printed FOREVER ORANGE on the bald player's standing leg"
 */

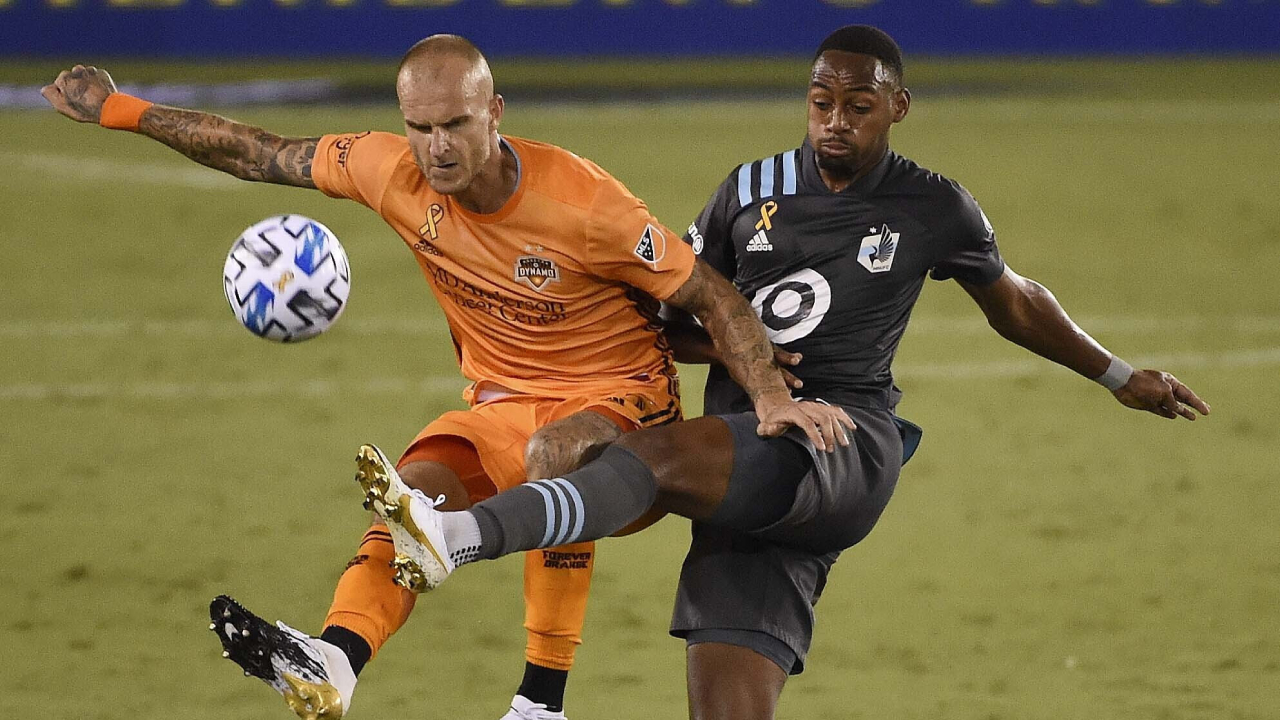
xmin=525 ymin=542 xmax=595 ymax=670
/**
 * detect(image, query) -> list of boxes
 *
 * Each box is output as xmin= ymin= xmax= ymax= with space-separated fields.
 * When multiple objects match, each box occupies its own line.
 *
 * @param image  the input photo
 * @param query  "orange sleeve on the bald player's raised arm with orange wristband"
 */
xmin=311 ymin=132 xmax=408 ymax=213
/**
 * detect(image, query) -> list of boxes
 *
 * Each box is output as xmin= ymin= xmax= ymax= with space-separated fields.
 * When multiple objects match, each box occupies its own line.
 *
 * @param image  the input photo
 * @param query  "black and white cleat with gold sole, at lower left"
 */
xmin=209 ymin=594 xmax=356 ymax=720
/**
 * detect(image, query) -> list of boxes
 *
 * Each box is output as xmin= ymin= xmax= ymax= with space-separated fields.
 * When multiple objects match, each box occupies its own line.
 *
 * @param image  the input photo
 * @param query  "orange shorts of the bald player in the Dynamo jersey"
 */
xmin=397 ymin=387 xmax=681 ymax=502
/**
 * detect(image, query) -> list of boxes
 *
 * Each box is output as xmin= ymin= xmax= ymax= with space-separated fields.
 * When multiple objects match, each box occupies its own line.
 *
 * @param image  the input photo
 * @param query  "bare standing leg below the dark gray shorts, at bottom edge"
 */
xmin=685 ymin=641 xmax=787 ymax=720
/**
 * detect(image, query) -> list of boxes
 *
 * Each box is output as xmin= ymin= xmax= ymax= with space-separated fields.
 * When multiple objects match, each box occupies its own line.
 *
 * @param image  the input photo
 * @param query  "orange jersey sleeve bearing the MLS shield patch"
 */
xmin=586 ymin=177 xmax=698 ymax=300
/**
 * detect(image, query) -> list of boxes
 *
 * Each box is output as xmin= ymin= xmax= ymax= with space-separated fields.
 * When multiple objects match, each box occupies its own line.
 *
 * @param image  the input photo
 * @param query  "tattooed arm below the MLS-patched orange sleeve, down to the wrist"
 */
xmin=667 ymin=260 xmax=790 ymax=401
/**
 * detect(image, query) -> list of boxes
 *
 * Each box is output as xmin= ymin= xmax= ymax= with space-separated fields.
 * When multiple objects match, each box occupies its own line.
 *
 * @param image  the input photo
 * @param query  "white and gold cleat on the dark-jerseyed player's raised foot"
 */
xmin=356 ymin=445 xmax=453 ymax=593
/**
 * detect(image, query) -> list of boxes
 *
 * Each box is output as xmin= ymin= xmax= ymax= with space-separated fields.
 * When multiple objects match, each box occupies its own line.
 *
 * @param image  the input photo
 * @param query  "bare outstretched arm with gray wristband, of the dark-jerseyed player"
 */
xmin=960 ymin=266 xmax=1210 ymax=420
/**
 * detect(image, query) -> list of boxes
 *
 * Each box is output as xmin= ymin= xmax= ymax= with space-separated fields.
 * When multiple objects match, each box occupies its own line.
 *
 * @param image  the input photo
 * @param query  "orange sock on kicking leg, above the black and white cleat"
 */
xmin=324 ymin=525 xmax=417 ymax=656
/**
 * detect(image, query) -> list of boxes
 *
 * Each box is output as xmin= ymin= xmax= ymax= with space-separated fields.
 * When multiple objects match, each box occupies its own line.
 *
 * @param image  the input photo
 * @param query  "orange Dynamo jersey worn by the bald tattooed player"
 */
xmin=312 ymin=132 xmax=695 ymax=397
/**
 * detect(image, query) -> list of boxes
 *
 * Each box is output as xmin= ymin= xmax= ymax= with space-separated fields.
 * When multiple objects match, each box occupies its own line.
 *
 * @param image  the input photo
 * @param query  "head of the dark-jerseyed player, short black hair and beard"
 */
xmin=808 ymin=26 xmax=911 ymax=178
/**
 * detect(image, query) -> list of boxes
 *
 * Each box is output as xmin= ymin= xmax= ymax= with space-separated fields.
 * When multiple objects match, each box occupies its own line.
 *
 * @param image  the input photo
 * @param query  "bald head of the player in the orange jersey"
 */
xmin=396 ymin=35 xmax=503 ymax=195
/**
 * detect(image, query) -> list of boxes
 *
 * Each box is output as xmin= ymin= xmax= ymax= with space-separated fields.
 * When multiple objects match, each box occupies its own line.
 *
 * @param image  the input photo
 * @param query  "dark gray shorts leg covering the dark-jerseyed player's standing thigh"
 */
xmin=671 ymin=523 xmax=838 ymax=675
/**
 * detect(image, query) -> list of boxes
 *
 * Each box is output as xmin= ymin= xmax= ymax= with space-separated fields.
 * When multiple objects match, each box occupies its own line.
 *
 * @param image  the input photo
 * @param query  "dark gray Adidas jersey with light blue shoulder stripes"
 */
xmin=685 ymin=142 xmax=1005 ymax=413
